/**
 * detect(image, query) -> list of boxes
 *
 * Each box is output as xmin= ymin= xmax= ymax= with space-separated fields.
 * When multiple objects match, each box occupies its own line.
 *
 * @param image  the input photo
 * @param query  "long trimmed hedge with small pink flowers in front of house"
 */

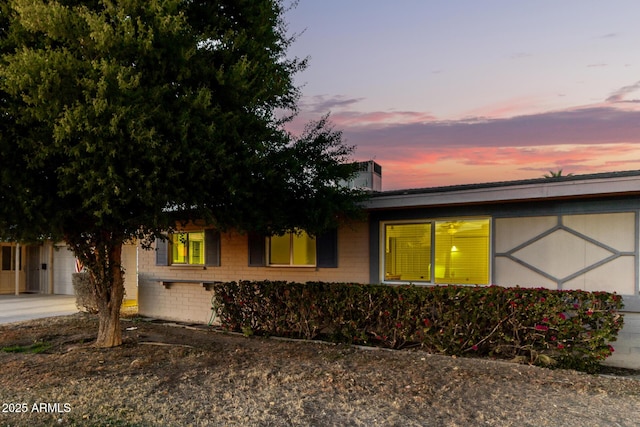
xmin=213 ymin=281 xmax=623 ymax=372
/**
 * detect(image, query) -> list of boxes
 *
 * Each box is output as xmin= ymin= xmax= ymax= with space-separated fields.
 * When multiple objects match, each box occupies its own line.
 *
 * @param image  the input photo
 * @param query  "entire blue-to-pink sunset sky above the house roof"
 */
xmin=288 ymin=0 xmax=640 ymax=190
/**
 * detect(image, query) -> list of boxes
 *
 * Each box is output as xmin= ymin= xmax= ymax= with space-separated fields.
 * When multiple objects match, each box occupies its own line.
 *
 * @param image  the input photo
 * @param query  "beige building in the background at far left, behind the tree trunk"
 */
xmin=0 ymin=241 xmax=138 ymax=304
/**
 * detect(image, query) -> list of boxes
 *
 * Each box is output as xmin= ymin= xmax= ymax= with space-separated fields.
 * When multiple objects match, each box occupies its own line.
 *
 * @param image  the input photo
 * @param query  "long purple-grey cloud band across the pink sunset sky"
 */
xmin=344 ymin=107 xmax=640 ymax=155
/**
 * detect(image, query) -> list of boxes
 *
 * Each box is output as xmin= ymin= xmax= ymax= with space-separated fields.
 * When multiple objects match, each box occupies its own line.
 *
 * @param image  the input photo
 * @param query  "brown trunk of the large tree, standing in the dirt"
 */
xmin=92 ymin=243 xmax=124 ymax=347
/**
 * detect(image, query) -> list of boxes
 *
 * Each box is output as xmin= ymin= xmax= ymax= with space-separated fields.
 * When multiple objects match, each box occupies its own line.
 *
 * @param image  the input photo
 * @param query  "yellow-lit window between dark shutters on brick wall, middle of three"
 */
xmin=268 ymin=231 xmax=316 ymax=266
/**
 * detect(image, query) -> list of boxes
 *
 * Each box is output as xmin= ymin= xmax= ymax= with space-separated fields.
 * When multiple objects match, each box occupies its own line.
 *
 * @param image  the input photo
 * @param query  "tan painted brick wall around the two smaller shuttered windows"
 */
xmin=138 ymin=222 xmax=369 ymax=323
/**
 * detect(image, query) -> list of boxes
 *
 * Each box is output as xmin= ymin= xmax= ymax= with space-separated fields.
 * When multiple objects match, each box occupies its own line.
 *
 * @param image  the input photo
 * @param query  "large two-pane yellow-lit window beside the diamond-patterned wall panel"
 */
xmin=383 ymin=219 xmax=489 ymax=284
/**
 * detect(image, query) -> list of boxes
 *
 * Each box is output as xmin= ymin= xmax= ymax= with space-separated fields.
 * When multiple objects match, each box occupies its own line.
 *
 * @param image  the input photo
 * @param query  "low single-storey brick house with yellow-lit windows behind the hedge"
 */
xmin=138 ymin=166 xmax=640 ymax=368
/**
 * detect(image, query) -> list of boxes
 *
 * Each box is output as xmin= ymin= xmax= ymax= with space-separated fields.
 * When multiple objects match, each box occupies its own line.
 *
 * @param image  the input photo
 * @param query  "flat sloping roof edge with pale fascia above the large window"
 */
xmin=365 ymin=170 xmax=640 ymax=209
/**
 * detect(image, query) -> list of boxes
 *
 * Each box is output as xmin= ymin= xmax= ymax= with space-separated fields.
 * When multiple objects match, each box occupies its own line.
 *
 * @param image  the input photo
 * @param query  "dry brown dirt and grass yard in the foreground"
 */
xmin=0 ymin=314 xmax=640 ymax=426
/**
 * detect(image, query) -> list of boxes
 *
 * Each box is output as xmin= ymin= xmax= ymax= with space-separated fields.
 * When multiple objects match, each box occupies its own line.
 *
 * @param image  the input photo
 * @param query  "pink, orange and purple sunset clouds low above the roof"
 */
xmin=293 ymin=96 xmax=640 ymax=189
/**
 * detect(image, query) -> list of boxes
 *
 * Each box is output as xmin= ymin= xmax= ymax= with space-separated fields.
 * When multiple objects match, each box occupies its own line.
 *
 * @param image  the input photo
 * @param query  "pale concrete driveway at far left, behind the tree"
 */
xmin=0 ymin=294 xmax=78 ymax=324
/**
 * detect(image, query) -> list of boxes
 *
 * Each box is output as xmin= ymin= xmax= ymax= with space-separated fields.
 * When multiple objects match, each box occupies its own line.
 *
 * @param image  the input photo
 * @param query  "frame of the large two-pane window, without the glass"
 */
xmin=378 ymin=216 xmax=493 ymax=286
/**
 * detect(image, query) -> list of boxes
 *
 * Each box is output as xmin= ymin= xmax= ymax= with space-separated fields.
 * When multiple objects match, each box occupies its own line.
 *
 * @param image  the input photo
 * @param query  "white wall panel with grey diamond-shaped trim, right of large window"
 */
xmin=493 ymin=212 xmax=638 ymax=295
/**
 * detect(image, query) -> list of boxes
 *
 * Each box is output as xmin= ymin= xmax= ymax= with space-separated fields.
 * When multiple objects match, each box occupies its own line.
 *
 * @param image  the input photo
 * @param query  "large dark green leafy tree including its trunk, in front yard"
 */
xmin=0 ymin=0 xmax=357 ymax=347
